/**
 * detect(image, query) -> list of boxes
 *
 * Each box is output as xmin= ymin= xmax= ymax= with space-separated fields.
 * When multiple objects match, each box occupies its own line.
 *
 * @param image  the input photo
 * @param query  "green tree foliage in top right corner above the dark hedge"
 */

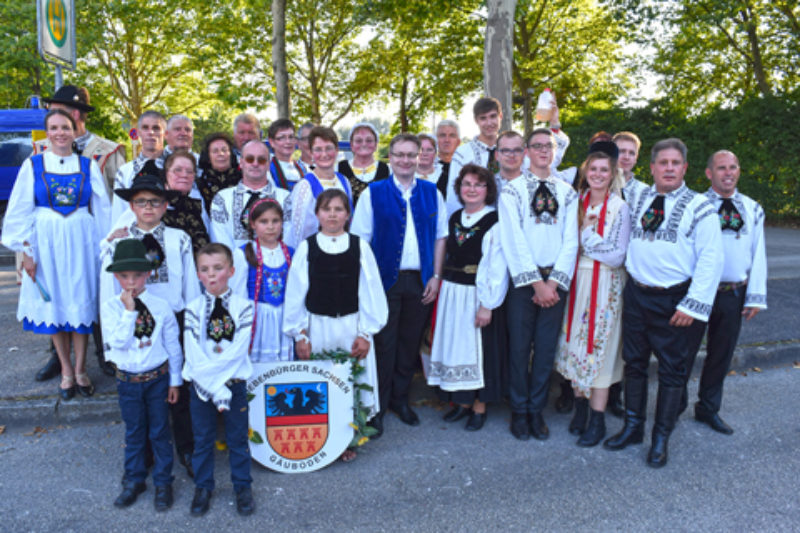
xmin=620 ymin=0 xmax=800 ymax=113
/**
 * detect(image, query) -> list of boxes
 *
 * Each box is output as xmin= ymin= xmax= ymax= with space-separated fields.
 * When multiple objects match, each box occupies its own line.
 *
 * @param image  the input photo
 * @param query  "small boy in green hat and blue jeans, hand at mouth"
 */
xmin=101 ymin=239 xmax=183 ymax=511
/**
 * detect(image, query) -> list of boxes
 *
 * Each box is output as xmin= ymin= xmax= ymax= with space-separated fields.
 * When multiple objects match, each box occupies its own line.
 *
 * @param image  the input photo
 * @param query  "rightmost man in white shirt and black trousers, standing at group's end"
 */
xmin=681 ymin=150 xmax=767 ymax=435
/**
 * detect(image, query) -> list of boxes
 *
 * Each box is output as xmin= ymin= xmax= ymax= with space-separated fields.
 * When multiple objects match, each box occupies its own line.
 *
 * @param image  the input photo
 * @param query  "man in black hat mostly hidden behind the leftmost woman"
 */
xmin=33 ymin=85 xmax=125 ymax=381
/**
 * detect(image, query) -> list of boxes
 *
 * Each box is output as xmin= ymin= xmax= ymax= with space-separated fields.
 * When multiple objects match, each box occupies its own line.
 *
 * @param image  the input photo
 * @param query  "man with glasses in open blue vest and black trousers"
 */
xmin=351 ymin=133 xmax=447 ymax=438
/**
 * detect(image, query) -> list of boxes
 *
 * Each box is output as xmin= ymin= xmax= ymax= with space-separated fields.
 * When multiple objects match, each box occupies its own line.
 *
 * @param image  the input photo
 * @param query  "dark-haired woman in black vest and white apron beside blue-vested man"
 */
xmin=428 ymin=164 xmax=508 ymax=431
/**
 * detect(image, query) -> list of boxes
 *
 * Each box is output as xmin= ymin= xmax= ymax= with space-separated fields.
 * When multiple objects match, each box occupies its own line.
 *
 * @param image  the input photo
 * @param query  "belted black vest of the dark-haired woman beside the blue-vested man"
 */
xmin=442 ymin=209 xmax=497 ymax=285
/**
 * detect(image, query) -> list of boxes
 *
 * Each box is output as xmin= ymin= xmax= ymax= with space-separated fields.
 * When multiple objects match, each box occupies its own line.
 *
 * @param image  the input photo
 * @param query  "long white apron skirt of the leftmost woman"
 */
xmin=17 ymin=207 xmax=99 ymax=330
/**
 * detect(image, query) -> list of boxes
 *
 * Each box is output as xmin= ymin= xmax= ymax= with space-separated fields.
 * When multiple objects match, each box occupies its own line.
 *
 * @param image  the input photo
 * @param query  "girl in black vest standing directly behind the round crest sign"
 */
xmin=283 ymin=189 xmax=389 ymax=461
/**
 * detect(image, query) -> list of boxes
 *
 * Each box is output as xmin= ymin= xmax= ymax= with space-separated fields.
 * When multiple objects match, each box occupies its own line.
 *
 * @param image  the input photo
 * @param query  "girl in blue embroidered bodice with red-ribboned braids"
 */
xmin=230 ymin=198 xmax=294 ymax=363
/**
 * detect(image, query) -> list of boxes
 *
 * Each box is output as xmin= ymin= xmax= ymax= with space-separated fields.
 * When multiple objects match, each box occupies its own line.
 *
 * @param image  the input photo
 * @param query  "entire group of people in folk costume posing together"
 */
xmin=2 ymin=86 xmax=767 ymax=514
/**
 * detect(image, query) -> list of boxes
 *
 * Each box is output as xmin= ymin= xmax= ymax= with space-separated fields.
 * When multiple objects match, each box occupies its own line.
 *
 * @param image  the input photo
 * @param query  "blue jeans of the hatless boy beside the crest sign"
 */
xmin=190 ymin=381 xmax=253 ymax=494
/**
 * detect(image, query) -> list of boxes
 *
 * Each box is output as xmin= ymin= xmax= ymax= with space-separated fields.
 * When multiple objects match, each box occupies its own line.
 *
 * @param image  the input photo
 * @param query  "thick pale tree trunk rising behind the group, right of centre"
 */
xmin=483 ymin=0 xmax=517 ymax=130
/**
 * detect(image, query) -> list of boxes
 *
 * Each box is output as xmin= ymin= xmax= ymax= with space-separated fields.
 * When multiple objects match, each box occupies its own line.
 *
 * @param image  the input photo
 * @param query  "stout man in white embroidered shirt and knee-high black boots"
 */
xmin=604 ymin=139 xmax=722 ymax=468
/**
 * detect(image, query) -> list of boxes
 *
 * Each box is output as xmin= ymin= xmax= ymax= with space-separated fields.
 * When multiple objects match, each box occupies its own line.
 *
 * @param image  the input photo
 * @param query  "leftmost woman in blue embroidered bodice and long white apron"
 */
xmin=3 ymin=110 xmax=111 ymax=400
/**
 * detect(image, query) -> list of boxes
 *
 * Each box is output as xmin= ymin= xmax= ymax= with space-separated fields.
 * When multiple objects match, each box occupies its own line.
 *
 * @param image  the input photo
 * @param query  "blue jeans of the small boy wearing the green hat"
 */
xmin=117 ymin=373 xmax=173 ymax=487
